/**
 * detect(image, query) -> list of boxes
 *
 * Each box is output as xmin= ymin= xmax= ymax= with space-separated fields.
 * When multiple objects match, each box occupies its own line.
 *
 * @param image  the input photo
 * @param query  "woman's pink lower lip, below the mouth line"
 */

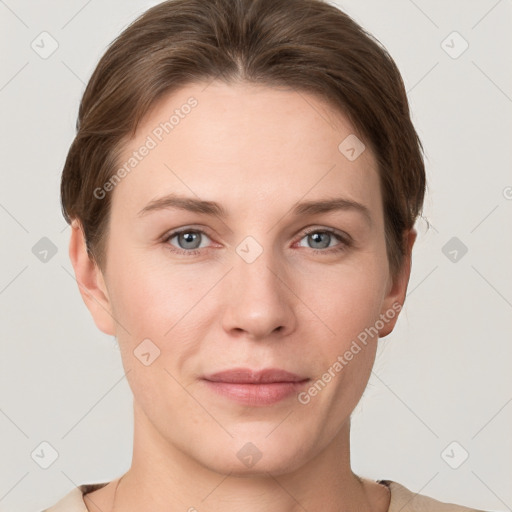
xmin=204 ymin=379 xmax=309 ymax=406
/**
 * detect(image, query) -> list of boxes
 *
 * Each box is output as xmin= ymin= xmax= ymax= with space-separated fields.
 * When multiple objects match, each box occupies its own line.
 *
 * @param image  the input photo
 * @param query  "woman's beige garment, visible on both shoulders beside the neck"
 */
xmin=42 ymin=480 xmax=483 ymax=512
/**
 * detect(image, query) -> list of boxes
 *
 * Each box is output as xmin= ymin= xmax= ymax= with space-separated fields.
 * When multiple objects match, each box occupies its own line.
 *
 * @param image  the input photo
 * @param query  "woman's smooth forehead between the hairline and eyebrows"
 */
xmin=113 ymin=82 xmax=380 ymax=217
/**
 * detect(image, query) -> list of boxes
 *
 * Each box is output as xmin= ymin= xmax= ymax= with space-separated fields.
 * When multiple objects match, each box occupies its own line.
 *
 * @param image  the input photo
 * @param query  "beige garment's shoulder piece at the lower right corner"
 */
xmin=379 ymin=480 xmax=490 ymax=512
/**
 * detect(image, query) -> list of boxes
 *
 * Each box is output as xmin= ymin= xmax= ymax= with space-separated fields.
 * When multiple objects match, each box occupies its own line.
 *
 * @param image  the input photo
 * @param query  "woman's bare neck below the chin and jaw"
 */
xmin=109 ymin=401 xmax=389 ymax=512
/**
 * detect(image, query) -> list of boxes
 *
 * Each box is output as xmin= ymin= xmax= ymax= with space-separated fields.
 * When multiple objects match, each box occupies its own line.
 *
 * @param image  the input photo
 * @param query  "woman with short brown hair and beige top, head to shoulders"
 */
xmin=44 ymin=0 xmax=488 ymax=512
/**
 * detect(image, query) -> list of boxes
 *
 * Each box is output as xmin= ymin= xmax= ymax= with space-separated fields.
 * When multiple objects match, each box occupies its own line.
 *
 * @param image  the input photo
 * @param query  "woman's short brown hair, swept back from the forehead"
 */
xmin=61 ymin=0 xmax=426 ymax=274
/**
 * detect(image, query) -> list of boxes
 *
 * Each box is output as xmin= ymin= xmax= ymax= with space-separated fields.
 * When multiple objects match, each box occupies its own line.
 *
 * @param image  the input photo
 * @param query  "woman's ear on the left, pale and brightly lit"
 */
xmin=69 ymin=219 xmax=115 ymax=336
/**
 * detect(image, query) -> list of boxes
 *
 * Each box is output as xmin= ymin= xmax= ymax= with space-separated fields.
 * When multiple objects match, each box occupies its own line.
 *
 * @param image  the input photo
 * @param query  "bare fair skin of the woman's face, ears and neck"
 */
xmin=70 ymin=82 xmax=416 ymax=512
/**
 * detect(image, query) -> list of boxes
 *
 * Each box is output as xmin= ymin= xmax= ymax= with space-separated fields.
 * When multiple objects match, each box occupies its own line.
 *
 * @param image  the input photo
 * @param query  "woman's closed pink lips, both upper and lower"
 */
xmin=203 ymin=368 xmax=310 ymax=406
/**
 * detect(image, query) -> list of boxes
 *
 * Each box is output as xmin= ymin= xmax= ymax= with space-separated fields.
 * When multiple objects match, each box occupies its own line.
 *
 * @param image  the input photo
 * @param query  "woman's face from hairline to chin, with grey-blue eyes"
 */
xmin=75 ymin=82 xmax=408 ymax=474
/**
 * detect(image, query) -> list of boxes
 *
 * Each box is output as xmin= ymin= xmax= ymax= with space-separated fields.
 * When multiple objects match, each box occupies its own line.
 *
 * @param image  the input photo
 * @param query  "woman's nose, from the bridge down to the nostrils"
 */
xmin=222 ymin=243 xmax=296 ymax=340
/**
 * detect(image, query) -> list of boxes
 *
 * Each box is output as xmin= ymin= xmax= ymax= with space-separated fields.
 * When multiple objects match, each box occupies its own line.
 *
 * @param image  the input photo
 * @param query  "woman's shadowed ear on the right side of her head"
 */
xmin=379 ymin=228 xmax=418 ymax=338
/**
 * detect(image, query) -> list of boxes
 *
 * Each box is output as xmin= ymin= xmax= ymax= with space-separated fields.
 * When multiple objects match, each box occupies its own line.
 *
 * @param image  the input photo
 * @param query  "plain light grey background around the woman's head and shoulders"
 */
xmin=0 ymin=0 xmax=512 ymax=512
